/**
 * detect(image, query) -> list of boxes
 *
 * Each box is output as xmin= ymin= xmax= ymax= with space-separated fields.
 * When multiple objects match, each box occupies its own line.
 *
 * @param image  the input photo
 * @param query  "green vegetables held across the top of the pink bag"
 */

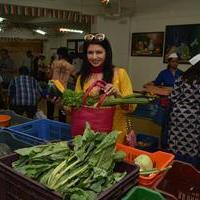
xmin=62 ymin=89 xmax=153 ymax=107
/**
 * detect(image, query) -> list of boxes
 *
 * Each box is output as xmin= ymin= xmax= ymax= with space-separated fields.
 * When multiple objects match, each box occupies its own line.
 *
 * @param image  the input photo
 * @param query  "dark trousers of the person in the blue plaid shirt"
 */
xmin=10 ymin=105 xmax=37 ymax=119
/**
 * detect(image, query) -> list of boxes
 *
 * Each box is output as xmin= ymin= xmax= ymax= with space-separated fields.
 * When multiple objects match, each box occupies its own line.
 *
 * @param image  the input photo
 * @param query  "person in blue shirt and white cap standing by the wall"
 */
xmin=144 ymin=53 xmax=182 ymax=149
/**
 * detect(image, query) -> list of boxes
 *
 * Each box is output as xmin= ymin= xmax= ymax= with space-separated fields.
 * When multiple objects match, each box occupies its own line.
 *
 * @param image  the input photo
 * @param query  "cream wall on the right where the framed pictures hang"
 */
xmin=127 ymin=0 xmax=200 ymax=89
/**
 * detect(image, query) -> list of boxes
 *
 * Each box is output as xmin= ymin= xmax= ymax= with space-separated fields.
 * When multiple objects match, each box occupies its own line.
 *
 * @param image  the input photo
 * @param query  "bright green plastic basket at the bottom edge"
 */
xmin=122 ymin=186 xmax=165 ymax=200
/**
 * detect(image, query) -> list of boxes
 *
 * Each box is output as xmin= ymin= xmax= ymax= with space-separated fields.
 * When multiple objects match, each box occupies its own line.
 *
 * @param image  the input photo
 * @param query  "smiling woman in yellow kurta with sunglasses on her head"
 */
xmin=75 ymin=33 xmax=133 ymax=142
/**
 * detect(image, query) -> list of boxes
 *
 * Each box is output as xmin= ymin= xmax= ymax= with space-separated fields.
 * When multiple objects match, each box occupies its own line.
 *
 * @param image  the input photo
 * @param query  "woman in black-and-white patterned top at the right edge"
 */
xmin=168 ymin=54 xmax=200 ymax=164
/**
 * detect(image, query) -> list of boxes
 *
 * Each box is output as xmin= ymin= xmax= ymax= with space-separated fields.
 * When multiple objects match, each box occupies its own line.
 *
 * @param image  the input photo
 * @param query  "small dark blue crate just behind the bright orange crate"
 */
xmin=136 ymin=133 xmax=159 ymax=152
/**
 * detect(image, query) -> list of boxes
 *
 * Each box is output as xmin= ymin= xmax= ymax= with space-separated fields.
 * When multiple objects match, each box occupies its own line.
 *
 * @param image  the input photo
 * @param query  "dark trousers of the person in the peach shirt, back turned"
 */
xmin=47 ymin=101 xmax=66 ymax=122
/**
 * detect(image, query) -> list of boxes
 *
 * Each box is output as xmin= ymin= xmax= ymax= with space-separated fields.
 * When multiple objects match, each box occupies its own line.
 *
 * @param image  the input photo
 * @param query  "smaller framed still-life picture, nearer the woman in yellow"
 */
xmin=131 ymin=32 xmax=164 ymax=56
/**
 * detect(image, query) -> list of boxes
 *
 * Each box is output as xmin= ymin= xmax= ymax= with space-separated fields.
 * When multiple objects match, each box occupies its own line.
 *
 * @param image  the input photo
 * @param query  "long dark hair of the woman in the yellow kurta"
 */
xmin=80 ymin=38 xmax=114 ymax=89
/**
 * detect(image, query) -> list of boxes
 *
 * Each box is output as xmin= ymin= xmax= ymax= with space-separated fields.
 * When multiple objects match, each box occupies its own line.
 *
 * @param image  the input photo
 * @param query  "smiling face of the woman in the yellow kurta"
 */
xmin=87 ymin=44 xmax=106 ymax=67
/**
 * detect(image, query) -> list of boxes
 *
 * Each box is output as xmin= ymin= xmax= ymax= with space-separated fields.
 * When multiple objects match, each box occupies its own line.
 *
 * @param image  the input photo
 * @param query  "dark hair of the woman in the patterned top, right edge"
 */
xmin=182 ymin=61 xmax=200 ymax=85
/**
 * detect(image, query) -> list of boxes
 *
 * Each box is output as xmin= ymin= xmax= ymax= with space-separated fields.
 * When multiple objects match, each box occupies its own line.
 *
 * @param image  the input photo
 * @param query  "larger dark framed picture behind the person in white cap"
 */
xmin=164 ymin=24 xmax=200 ymax=63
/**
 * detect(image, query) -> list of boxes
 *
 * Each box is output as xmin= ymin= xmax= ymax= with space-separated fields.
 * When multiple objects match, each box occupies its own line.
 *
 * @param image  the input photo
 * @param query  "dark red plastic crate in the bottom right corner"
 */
xmin=154 ymin=160 xmax=200 ymax=200
